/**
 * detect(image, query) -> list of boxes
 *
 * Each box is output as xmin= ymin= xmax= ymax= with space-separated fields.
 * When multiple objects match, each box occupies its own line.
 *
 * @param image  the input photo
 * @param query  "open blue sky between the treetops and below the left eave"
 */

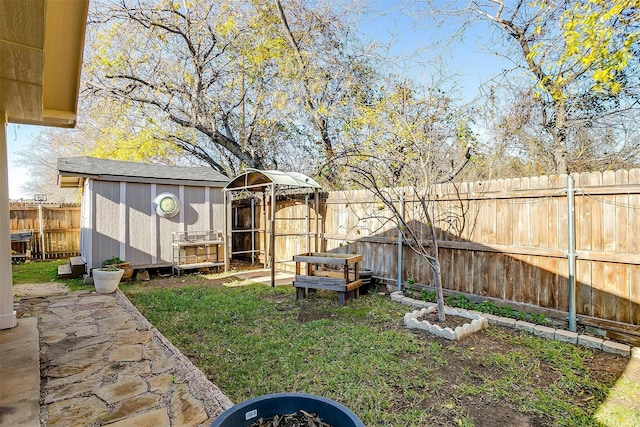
xmin=7 ymin=0 xmax=509 ymax=199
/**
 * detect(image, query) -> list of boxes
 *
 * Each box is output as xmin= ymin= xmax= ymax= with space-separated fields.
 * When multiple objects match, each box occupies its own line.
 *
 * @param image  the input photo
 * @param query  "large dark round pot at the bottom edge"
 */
xmin=211 ymin=393 xmax=364 ymax=427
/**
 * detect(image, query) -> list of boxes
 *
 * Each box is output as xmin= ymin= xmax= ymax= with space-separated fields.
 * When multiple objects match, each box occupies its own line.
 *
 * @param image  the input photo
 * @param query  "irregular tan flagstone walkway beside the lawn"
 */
xmin=39 ymin=291 xmax=233 ymax=427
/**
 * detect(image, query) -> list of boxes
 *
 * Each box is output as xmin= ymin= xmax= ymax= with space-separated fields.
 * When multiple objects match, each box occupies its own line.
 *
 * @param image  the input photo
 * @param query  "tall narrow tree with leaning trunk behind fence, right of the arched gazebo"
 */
xmin=273 ymin=0 xmax=376 ymax=188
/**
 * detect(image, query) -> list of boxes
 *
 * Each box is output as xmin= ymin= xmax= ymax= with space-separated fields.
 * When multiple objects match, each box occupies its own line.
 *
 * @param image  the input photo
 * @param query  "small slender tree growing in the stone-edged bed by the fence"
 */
xmin=344 ymin=82 xmax=475 ymax=321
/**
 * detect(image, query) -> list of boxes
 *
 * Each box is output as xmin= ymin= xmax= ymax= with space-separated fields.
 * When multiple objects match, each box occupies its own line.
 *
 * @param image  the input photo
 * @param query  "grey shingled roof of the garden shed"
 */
xmin=58 ymin=156 xmax=229 ymax=188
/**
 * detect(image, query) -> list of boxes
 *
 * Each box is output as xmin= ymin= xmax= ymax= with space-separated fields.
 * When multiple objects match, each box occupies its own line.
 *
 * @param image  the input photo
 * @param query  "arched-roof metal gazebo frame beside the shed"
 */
xmin=222 ymin=169 xmax=322 ymax=287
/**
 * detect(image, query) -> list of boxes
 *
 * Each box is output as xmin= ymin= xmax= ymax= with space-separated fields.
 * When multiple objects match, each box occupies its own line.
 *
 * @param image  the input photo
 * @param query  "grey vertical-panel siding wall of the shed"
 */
xmin=83 ymin=180 xmax=224 ymax=268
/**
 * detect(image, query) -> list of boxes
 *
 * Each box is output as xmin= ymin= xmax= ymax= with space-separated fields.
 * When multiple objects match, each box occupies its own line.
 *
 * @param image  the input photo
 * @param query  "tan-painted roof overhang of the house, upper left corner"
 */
xmin=0 ymin=0 xmax=89 ymax=127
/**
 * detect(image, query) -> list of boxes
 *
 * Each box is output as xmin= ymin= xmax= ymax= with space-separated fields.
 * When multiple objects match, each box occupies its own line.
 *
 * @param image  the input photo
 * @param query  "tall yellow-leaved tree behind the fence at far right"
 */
xmin=422 ymin=0 xmax=640 ymax=173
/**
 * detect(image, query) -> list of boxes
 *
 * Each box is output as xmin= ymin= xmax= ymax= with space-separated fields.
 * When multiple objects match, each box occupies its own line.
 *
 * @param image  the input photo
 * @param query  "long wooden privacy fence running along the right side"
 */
xmin=232 ymin=169 xmax=640 ymax=342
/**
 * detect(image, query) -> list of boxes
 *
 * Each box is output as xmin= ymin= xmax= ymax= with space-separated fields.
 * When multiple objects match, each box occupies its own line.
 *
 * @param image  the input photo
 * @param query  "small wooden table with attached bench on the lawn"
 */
xmin=293 ymin=252 xmax=362 ymax=305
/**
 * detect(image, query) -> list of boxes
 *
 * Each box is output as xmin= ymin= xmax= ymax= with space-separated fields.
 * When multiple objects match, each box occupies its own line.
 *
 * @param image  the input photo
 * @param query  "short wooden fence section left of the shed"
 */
xmin=9 ymin=202 xmax=80 ymax=259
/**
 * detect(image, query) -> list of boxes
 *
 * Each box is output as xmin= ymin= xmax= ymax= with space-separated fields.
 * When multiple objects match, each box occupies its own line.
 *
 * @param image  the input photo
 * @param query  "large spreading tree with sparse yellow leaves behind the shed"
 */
xmin=86 ymin=0 xmax=376 ymax=179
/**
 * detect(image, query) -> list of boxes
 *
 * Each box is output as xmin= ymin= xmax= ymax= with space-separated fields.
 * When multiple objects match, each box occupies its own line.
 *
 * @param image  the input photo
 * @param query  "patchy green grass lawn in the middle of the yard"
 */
xmin=121 ymin=281 xmax=627 ymax=427
